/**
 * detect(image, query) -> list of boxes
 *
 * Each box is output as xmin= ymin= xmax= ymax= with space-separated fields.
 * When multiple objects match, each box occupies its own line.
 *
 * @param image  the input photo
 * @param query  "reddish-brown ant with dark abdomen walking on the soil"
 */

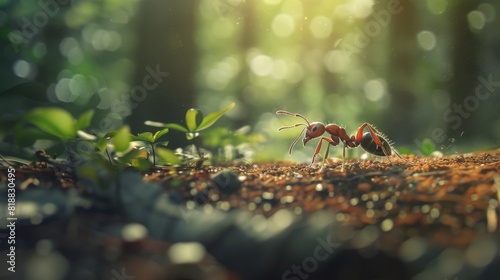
xmin=276 ymin=110 xmax=403 ymax=172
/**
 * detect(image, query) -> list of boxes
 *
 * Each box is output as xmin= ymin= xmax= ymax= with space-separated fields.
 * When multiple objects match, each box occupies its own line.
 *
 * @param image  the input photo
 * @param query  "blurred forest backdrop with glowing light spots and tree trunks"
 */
xmin=0 ymin=0 xmax=500 ymax=161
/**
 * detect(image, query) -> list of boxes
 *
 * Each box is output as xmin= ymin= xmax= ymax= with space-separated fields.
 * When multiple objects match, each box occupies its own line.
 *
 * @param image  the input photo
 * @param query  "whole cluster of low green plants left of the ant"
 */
xmin=0 ymin=103 xmax=241 ymax=170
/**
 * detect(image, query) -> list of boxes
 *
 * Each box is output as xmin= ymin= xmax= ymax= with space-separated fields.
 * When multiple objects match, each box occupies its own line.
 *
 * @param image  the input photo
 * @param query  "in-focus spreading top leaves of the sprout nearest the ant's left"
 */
xmin=144 ymin=102 xmax=235 ymax=140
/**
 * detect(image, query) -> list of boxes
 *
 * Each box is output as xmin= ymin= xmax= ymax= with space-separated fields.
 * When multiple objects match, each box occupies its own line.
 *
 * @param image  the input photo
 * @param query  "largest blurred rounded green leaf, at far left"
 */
xmin=24 ymin=107 xmax=77 ymax=139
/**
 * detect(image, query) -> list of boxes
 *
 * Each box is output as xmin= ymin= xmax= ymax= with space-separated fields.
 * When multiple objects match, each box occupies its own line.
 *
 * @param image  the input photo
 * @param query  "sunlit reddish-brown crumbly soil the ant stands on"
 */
xmin=148 ymin=151 xmax=500 ymax=249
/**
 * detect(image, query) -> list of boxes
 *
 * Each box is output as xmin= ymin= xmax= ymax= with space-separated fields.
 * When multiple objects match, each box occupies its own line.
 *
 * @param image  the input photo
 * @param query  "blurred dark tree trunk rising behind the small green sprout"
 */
xmin=128 ymin=0 xmax=198 ymax=148
